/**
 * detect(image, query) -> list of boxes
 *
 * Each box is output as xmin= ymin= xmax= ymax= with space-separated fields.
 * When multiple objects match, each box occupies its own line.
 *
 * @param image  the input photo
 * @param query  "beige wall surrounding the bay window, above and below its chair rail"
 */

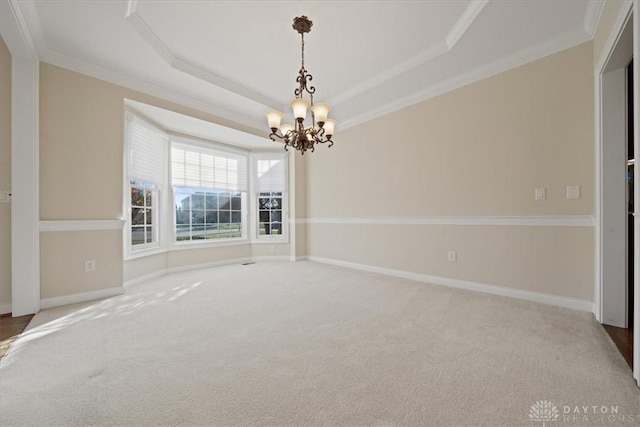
xmin=40 ymin=63 xmax=289 ymax=298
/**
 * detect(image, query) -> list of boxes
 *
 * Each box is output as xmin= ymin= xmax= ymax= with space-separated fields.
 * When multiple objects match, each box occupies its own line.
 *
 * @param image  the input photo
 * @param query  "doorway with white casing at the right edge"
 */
xmin=596 ymin=0 xmax=640 ymax=385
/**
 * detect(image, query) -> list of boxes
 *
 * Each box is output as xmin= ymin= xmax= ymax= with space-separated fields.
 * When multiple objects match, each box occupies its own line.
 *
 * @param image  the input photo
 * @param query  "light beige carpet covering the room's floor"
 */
xmin=0 ymin=262 xmax=640 ymax=427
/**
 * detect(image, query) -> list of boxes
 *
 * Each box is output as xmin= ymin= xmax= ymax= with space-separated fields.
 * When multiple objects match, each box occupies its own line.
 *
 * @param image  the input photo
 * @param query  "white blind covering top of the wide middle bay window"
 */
xmin=171 ymin=142 xmax=248 ymax=191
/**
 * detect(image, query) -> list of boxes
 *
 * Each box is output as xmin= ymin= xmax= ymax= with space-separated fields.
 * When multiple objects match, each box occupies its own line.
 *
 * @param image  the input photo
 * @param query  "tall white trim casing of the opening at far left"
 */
xmin=0 ymin=0 xmax=40 ymax=316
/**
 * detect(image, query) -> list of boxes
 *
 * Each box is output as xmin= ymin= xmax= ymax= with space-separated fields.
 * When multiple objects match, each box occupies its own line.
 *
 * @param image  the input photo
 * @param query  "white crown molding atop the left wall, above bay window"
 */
xmin=41 ymin=50 xmax=264 ymax=132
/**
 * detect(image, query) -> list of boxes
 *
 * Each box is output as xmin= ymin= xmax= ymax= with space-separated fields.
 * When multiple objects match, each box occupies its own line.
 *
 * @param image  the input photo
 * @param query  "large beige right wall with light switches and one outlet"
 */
xmin=307 ymin=42 xmax=594 ymax=301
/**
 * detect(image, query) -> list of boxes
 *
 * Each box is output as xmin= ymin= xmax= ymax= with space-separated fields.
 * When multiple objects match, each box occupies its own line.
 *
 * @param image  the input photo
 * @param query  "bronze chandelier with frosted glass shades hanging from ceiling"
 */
xmin=266 ymin=16 xmax=336 ymax=155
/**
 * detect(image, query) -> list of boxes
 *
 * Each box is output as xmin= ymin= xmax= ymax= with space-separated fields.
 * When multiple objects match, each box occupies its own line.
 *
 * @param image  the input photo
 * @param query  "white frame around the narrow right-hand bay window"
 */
xmin=249 ymin=151 xmax=289 ymax=244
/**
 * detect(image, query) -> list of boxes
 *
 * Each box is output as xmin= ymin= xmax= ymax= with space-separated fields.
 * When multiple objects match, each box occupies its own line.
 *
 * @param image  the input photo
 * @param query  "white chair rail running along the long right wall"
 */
xmin=295 ymin=215 xmax=595 ymax=227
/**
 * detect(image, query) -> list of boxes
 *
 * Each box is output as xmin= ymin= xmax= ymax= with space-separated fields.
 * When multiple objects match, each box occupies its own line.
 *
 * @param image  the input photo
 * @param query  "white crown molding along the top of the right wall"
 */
xmin=340 ymin=29 xmax=591 ymax=131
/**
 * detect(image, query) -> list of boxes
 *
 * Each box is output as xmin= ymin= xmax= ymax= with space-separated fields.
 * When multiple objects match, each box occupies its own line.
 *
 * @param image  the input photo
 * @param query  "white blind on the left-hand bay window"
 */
xmin=127 ymin=115 xmax=168 ymax=186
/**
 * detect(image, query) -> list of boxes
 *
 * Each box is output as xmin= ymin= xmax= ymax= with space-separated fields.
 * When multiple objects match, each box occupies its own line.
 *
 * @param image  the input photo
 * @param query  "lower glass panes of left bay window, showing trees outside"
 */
xmin=131 ymin=181 xmax=156 ymax=245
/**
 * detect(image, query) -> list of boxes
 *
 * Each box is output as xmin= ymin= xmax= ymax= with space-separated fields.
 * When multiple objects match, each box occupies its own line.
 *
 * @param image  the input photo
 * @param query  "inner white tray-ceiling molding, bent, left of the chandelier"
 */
xmin=125 ymin=0 xmax=281 ymax=109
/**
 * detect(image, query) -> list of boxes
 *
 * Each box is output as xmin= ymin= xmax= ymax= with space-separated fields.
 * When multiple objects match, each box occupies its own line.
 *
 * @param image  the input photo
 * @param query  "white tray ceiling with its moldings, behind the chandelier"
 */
xmin=12 ymin=0 xmax=602 ymax=135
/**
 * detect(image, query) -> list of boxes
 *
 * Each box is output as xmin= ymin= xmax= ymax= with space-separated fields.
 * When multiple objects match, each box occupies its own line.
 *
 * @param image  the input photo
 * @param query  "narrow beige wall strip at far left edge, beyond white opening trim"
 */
xmin=0 ymin=37 xmax=11 ymax=314
